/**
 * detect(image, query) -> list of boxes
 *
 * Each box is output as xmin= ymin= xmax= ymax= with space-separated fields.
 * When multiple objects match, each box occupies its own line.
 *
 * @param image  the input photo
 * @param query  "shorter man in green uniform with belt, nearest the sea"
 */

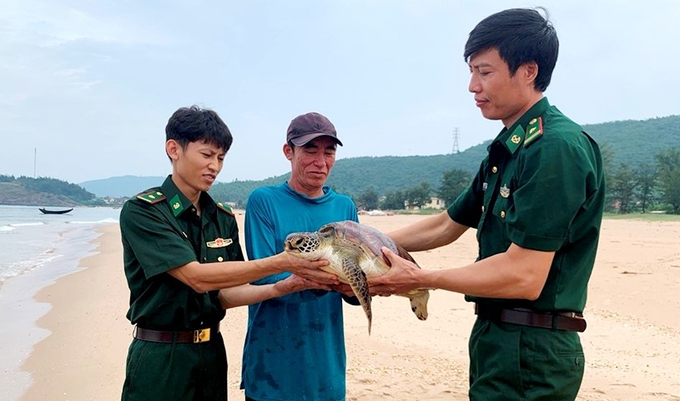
xmin=120 ymin=106 xmax=338 ymax=401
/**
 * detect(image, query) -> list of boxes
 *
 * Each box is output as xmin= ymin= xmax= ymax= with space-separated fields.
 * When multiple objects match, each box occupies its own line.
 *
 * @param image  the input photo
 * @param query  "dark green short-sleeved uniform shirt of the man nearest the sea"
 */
xmin=120 ymin=177 xmax=244 ymax=331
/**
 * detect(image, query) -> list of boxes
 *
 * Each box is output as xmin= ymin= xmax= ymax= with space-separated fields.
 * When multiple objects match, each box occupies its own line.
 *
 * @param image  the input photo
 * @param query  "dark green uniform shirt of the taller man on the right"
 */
xmin=448 ymin=98 xmax=604 ymax=312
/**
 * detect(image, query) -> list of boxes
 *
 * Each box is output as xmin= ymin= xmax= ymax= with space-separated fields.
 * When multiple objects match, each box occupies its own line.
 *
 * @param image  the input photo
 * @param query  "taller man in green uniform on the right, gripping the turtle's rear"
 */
xmin=371 ymin=9 xmax=604 ymax=401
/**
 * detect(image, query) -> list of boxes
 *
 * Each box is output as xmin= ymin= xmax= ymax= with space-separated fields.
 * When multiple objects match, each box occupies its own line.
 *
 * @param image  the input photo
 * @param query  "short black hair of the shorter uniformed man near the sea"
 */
xmin=165 ymin=105 xmax=233 ymax=153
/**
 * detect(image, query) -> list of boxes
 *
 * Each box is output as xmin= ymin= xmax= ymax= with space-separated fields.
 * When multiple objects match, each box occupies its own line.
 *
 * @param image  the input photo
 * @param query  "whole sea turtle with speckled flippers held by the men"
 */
xmin=284 ymin=220 xmax=430 ymax=334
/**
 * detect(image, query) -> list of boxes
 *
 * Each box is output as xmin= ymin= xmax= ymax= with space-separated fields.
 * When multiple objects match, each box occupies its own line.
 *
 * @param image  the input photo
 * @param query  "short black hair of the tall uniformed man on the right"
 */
xmin=463 ymin=7 xmax=560 ymax=92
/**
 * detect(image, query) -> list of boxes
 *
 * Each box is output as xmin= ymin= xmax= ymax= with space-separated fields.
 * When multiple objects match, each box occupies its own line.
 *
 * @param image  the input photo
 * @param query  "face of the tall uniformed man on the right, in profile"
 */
xmin=468 ymin=49 xmax=535 ymax=127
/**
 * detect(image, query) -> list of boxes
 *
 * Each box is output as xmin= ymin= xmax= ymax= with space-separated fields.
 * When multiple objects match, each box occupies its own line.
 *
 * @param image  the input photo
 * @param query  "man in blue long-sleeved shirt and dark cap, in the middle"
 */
xmin=241 ymin=113 xmax=358 ymax=401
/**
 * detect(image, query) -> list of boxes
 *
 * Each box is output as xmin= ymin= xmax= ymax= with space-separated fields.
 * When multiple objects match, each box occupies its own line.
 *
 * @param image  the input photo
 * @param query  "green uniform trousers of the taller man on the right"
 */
xmin=469 ymin=319 xmax=585 ymax=401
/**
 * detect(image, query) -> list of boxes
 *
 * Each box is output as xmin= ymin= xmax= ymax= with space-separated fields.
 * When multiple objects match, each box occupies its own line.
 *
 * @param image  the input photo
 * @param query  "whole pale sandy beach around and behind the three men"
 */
xmin=17 ymin=212 xmax=680 ymax=401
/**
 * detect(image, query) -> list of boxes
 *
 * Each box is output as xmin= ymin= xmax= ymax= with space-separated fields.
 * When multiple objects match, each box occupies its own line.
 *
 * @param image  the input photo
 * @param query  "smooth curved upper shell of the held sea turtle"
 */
xmin=319 ymin=220 xmax=416 ymax=267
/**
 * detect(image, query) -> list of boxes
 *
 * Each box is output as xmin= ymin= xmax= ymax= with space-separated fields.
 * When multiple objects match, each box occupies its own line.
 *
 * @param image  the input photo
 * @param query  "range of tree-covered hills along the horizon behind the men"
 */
xmin=0 ymin=115 xmax=680 ymax=206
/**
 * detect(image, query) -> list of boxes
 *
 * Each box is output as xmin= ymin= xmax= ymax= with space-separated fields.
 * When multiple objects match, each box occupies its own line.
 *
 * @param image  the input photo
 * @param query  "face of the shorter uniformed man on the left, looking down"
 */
xmin=168 ymin=142 xmax=226 ymax=196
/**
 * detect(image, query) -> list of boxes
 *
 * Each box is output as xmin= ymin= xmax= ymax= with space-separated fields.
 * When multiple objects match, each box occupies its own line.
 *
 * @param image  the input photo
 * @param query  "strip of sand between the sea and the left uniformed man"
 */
xmin=20 ymin=224 xmax=132 ymax=400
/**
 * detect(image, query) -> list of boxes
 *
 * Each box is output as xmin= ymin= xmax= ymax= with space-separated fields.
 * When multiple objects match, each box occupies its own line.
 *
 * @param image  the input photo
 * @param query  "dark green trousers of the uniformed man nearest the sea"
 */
xmin=122 ymin=333 xmax=227 ymax=401
